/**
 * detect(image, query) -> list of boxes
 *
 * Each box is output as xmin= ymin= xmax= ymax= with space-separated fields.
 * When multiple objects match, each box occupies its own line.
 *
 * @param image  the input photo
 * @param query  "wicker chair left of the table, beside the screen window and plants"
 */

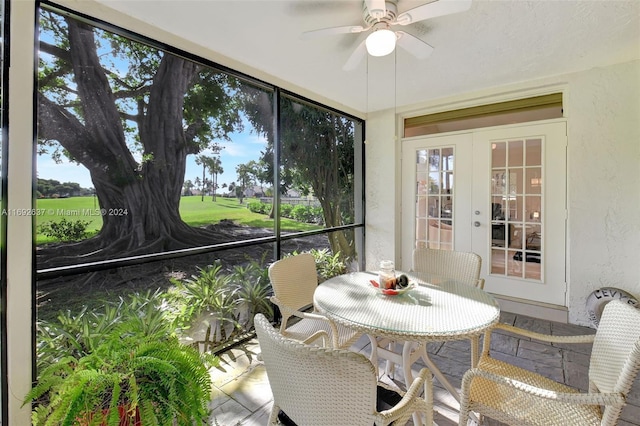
xmin=269 ymin=253 xmax=361 ymax=348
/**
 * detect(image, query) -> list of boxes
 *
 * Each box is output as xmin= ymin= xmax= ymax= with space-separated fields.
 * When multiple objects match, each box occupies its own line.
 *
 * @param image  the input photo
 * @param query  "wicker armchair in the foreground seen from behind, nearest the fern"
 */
xmin=255 ymin=314 xmax=433 ymax=426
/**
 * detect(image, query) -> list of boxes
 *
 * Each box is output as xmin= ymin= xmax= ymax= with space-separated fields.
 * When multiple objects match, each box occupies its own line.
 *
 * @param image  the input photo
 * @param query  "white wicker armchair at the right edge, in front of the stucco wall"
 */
xmin=460 ymin=300 xmax=640 ymax=426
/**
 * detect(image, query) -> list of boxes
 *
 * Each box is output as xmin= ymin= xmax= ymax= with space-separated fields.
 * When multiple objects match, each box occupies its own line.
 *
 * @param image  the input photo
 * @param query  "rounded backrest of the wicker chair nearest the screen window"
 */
xmin=269 ymin=253 xmax=318 ymax=310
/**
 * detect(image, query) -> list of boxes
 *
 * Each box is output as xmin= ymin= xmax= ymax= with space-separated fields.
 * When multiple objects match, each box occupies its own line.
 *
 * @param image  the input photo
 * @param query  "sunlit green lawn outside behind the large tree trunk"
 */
xmin=36 ymin=195 xmax=321 ymax=244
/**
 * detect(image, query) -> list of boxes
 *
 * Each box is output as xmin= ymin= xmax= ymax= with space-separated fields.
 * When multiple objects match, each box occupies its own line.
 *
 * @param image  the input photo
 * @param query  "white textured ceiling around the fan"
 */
xmin=94 ymin=0 xmax=640 ymax=113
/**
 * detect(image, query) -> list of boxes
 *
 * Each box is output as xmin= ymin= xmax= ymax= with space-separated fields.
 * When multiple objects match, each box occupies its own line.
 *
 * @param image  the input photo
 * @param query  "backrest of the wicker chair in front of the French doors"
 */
xmin=412 ymin=248 xmax=483 ymax=287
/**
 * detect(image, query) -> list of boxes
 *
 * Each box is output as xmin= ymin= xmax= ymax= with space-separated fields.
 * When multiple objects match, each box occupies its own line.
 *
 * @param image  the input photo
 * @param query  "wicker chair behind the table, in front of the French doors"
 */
xmin=369 ymin=248 xmax=484 ymax=374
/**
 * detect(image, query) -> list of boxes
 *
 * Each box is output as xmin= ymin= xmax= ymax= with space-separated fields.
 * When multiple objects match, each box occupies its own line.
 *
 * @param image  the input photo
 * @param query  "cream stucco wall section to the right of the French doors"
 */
xmin=565 ymin=61 xmax=640 ymax=325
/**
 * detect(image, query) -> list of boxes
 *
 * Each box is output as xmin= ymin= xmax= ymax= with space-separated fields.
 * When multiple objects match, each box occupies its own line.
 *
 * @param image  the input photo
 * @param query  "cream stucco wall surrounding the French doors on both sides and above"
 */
xmin=365 ymin=60 xmax=640 ymax=325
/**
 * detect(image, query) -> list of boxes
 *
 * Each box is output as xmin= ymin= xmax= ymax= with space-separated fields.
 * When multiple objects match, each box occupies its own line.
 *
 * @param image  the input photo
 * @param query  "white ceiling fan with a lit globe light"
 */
xmin=302 ymin=0 xmax=472 ymax=71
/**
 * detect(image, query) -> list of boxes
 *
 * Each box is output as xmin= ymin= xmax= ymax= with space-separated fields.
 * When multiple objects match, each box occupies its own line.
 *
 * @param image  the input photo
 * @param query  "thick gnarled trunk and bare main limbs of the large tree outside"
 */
xmin=38 ymin=19 xmax=218 ymax=264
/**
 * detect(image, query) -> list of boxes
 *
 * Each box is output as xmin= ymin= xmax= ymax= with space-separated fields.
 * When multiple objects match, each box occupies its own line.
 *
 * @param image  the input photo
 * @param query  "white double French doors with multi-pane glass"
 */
xmin=401 ymin=121 xmax=566 ymax=306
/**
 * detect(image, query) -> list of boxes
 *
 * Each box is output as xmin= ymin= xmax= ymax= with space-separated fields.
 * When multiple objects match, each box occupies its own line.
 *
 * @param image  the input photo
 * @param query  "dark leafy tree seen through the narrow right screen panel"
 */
xmin=244 ymin=95 xmax=356 ymax=259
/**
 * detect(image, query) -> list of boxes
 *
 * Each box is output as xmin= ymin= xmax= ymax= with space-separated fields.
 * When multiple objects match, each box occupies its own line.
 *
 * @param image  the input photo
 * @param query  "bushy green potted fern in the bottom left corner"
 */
xmin=24 ymin=292 xmax=217 ymax=426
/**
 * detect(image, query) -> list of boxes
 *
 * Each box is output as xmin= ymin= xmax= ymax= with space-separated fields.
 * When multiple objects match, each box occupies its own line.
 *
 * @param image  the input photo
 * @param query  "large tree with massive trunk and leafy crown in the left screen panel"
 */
xmin=37 ymin=11 xmax=241 ymax=264
